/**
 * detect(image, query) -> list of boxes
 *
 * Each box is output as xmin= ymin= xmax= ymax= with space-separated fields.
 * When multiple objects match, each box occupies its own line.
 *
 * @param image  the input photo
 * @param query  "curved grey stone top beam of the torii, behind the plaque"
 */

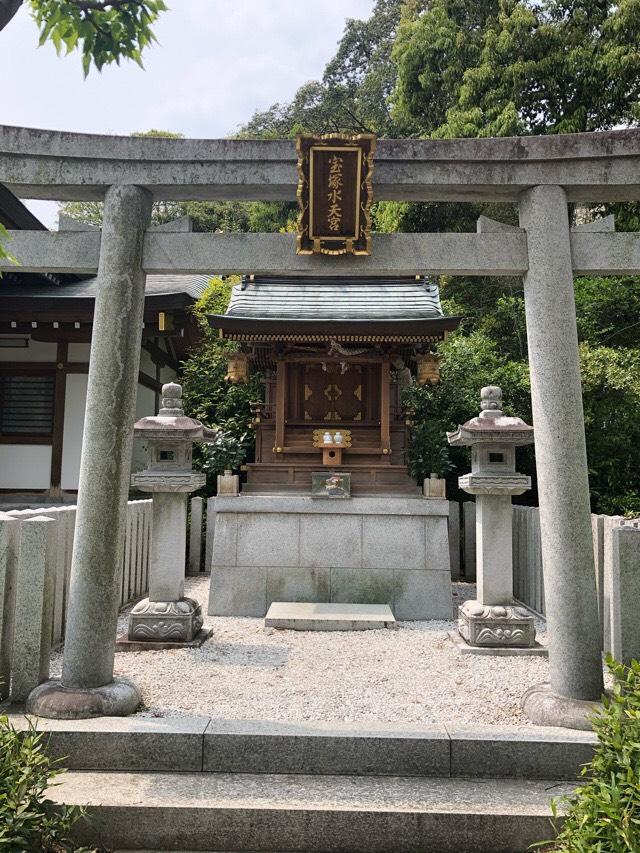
xmin=0 ymin=126 xmax=640 ymax=202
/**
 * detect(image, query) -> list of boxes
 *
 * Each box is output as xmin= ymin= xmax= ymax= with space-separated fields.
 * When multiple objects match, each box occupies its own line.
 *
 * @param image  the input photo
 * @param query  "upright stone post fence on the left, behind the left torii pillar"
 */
xmin=0 ymin=500 xmax=152 ymax=702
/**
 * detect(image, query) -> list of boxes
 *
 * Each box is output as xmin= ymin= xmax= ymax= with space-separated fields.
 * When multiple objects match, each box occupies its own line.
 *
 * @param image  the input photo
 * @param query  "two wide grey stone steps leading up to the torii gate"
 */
xmin=32 ymin=718 xmax=594 ymax=853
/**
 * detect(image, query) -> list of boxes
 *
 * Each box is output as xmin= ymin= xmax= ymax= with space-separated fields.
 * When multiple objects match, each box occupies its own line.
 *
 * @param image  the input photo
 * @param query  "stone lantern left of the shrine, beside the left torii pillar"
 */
xmin=128 ymin=382 xmax=210 ymax=643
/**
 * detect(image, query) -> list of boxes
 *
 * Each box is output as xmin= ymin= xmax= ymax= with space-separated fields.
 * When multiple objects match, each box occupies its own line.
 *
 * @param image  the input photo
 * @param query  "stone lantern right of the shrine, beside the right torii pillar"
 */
xmin=447 ymin=385 xmax=535 ymax=648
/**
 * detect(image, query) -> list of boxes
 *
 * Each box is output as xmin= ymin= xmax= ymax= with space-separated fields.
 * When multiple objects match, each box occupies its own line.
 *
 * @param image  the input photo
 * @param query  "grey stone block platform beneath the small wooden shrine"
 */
xmin=208 ymin=495 xmax=453 ymax=619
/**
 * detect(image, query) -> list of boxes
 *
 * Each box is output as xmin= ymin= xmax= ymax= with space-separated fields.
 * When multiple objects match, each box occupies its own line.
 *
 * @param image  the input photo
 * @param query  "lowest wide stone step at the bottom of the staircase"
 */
xmin=48 ymin=772 xmax=573 ymax=853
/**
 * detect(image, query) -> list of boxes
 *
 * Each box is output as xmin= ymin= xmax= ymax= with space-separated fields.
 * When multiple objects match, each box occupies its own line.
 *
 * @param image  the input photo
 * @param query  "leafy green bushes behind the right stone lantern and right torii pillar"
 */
xmin=396 ymin=312 xmax=640 ymax=516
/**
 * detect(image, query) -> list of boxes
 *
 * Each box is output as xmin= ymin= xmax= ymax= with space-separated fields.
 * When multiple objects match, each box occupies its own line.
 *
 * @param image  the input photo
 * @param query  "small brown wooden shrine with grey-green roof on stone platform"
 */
xmin=209 ymin=276 xmax=459 ymax=495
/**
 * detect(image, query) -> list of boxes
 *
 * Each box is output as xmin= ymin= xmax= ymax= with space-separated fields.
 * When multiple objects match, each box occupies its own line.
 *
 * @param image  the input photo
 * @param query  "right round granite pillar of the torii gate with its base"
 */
xmin=519 ymin=186 xmax=603 ymax=729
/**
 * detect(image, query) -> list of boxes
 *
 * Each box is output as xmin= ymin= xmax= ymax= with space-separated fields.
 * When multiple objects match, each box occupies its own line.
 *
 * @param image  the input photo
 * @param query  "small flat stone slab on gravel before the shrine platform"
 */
xmin=264 ymin=601 xmax=397 ymax=631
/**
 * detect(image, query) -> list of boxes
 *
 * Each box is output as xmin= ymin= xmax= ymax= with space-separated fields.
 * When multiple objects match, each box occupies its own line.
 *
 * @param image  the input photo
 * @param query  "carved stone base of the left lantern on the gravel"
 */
xmin=128 ymin=598 xmax=203 ymax=643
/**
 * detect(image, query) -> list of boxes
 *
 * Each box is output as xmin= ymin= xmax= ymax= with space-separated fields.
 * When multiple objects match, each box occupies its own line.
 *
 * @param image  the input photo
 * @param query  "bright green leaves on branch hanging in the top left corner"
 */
xmin=9 ymin=0 xmax=167 ymax=77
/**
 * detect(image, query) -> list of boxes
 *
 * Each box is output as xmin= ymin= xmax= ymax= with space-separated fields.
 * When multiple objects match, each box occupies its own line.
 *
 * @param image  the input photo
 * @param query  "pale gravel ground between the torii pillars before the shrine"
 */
xmin=52 ymin=577 xmax=548 ymax=726
